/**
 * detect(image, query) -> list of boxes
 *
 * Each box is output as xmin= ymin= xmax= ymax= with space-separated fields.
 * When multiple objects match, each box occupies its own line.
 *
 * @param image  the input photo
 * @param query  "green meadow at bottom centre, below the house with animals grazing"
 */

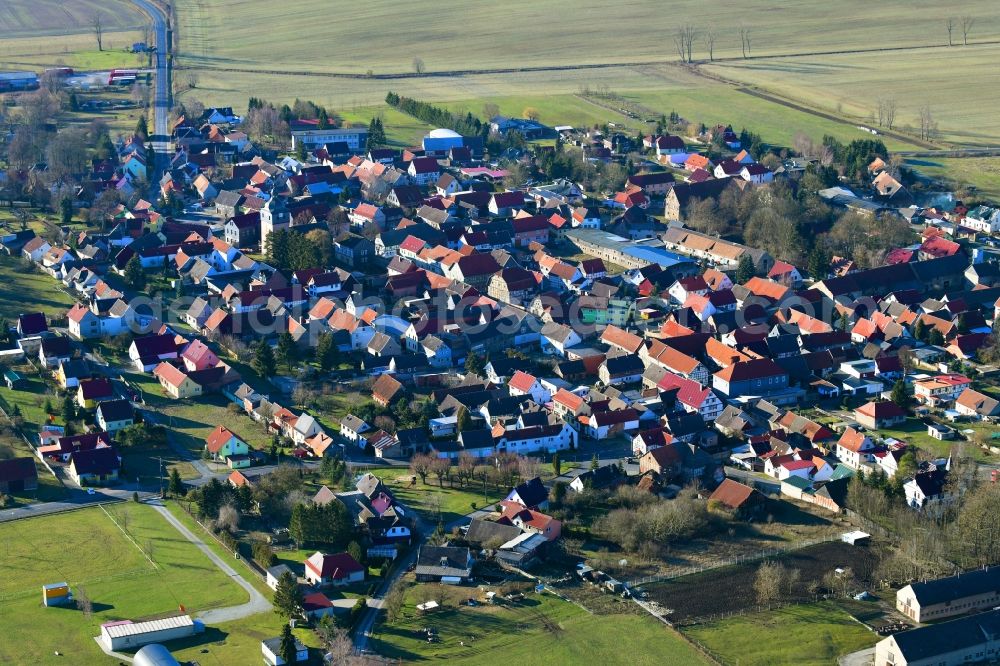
xmin=372 ymin=585 xmax=707 ymax=666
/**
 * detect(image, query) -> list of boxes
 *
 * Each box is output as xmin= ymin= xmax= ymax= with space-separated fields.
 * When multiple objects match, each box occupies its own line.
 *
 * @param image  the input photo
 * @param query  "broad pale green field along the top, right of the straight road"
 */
xmin=176 ymin=0 xmax=998 ymax=74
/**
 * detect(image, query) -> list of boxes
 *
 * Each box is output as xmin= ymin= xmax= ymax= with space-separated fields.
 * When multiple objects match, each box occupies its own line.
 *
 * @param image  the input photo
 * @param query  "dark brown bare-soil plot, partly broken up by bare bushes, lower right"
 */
xmin=644 ymin=541 xmax=877 ymax=624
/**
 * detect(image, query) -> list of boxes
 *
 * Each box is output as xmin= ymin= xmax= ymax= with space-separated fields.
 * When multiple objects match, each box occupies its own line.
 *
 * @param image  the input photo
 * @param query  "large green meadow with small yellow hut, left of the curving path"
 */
xmin=0 ymin=503 xmax=252 ymax=664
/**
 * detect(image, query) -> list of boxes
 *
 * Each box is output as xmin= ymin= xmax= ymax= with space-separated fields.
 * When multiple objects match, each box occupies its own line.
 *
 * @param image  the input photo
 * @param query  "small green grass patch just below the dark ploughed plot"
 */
xmin=684 ymin=603 xmax=879 ymax=666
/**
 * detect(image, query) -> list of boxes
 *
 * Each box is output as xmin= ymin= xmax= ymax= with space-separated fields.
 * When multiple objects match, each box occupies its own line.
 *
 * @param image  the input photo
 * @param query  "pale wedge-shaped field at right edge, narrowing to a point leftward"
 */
xmin=703 ymin=44 xmax=1000 ymax=146
